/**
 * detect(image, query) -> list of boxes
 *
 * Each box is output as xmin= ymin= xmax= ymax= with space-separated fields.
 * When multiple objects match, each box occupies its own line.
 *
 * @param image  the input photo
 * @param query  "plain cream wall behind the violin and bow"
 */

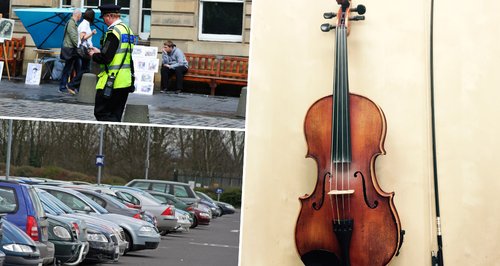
xmin=240 ymin=0 xmax=500 ymax=266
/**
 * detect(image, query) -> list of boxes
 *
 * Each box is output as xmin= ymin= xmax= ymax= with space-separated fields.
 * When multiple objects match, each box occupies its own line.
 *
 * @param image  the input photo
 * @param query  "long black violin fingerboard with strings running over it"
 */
xmin=332 ymin=25 xmax=351 ymax=163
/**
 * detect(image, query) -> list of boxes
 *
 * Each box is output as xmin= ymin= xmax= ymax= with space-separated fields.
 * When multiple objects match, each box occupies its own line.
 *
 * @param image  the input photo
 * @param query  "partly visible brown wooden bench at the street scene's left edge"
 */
xmin=0 ymin=36 xmax=26 ymax=76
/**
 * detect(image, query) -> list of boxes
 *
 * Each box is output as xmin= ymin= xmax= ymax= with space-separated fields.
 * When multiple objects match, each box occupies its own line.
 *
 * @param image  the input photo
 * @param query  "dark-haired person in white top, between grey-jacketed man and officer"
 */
xmin=66 ymin=8 xmax=97 ymax=94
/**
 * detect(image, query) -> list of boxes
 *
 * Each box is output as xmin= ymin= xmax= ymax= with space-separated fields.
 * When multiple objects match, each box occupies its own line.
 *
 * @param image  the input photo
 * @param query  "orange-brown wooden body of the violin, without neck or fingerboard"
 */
xmin=295 ymin=93 xmax=401 ymax=266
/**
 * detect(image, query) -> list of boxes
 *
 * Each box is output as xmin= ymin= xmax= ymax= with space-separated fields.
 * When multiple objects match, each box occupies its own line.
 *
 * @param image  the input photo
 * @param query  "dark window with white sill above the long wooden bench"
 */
xmin=199 ymin=0 xmax=244 ymax=42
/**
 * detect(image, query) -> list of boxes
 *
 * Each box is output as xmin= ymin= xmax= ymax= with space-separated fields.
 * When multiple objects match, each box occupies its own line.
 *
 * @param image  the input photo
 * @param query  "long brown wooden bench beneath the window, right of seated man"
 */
xmin=184 ymin=53 xmax=248 ymax=95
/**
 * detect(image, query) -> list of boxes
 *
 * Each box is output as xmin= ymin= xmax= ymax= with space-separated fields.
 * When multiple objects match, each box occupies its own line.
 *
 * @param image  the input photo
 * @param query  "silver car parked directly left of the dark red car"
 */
xmin=111 ymin=186 xmax=177 ymax=232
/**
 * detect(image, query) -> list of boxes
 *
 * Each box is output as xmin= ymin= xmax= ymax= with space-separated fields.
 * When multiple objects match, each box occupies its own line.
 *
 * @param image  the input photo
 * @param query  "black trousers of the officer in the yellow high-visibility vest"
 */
xmin=94 ymin=88 xmax=131 ymax=122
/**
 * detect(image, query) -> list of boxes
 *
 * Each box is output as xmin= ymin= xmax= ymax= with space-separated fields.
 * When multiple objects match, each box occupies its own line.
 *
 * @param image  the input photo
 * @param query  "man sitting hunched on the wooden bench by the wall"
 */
xmin=160 ymin=41 xmax=188 ymax=94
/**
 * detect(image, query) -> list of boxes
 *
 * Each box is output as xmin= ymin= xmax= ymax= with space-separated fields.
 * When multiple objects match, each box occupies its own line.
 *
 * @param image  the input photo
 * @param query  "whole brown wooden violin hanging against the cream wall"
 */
xmin=295 ymin=0 xmax=404 ymax=266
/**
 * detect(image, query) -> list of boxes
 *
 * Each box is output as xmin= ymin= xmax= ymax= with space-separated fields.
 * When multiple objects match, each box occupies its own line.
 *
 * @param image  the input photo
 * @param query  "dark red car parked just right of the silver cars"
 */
xmin=146 ymin=190 xmax=211 ymax=228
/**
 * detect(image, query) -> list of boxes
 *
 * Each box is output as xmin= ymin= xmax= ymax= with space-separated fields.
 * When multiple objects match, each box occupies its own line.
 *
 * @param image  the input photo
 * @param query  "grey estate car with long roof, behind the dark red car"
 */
xmin=125 ymin=179 xmax=200 ymax=205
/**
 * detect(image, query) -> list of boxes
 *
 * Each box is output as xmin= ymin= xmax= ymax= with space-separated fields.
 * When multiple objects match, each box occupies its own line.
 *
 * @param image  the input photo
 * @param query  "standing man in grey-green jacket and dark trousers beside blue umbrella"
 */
xmin=59 ymin=9 xmax=82 ymax=93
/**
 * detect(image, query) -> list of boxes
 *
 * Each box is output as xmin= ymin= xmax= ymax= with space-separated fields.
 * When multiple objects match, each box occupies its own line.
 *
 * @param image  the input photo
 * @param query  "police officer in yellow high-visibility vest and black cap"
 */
xmin=89 ymin=4 xmax=135 ymax=122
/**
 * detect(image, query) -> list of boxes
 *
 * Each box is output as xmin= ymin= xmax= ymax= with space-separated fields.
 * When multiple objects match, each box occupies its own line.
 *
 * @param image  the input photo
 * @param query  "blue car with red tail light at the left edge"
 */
xmin=0 ymin=180 xmax=55 ymax=265
